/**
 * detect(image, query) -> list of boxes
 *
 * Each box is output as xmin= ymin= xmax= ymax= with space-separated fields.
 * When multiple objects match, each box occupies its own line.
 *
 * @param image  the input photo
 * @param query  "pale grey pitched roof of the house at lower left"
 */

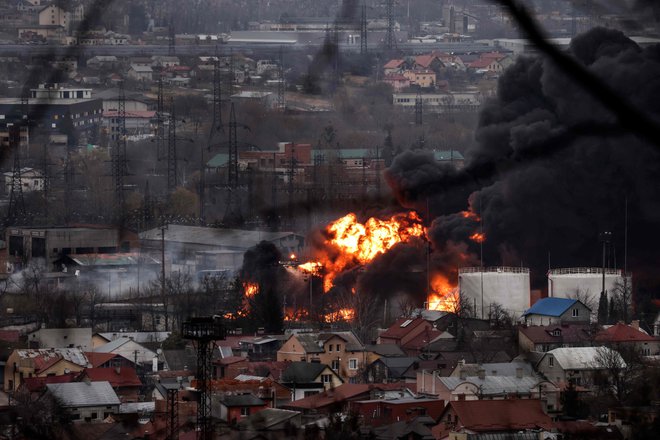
xmin=46 ymin=381 xmax=121 ymax=407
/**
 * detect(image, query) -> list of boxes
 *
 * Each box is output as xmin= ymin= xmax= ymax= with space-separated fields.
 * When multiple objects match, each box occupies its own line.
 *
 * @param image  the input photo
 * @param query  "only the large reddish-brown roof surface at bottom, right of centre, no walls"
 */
xmin=445 ymin=399 xmax=554 ymax=432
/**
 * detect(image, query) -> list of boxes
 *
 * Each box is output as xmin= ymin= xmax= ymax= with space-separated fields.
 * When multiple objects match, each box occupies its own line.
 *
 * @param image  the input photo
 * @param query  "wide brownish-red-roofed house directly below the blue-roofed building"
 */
xmin=518 ymin=324 xmax=594 ymax=352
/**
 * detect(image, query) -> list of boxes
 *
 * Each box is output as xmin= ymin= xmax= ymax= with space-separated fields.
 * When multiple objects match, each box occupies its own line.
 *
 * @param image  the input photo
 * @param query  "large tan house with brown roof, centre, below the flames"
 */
xmin=277 ymin=331 xmax=367 ymax=380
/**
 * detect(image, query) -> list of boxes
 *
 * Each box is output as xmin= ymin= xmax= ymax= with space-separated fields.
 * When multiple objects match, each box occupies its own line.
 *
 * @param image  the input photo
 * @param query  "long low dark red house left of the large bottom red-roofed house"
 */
xmin=349 ymin=397 xmax=445 ymax=427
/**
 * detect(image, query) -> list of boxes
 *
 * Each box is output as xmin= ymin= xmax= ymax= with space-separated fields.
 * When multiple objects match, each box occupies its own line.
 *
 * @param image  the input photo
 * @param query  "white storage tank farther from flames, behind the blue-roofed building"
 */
xmin=548 ymin=267 xmax=632 ymax=313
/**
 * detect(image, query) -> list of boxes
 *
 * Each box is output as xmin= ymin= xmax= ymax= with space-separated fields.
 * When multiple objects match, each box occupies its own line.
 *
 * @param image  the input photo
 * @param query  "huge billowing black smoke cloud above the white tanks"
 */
xmin=388 ymin=29 xmax=660 ymax=286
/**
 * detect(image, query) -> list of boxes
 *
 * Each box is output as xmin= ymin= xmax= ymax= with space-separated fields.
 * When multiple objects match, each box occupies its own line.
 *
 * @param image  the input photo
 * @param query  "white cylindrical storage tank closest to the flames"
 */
xmin=458 ymin=267 xmax=530 ymax=319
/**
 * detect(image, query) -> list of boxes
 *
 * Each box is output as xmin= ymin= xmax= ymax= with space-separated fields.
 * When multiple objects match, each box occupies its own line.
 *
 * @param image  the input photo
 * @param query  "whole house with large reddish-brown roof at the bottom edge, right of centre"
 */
xmin=432 ymin=399 xmax=555 ymax=440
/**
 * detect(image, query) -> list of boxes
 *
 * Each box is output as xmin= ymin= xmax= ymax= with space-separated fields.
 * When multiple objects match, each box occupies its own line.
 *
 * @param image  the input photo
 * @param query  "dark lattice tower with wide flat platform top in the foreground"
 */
xmin=181 ymin=316 xmax=225 ymax=440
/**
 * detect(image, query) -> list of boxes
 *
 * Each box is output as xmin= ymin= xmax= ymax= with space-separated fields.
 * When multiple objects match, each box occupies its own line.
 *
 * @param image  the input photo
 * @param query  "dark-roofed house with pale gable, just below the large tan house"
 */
xmin=280 ymin=362 xmax=344 ymax=400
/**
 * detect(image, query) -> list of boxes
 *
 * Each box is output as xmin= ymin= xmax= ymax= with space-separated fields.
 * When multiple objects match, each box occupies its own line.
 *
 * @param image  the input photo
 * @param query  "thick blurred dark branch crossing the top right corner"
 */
xmin=493 ymin=0 xmax=660 ymax=148
